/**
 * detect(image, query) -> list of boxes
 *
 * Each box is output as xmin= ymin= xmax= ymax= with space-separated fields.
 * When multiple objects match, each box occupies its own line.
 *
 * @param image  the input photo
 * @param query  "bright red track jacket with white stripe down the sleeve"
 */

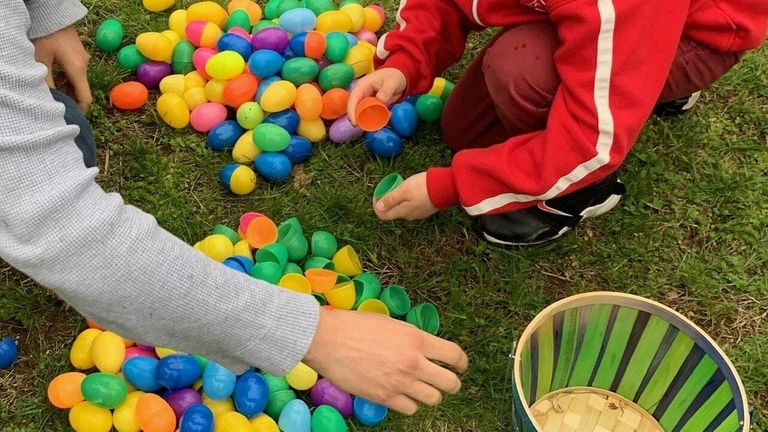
xmin=377 ymin=0 xmax=768 ymax=215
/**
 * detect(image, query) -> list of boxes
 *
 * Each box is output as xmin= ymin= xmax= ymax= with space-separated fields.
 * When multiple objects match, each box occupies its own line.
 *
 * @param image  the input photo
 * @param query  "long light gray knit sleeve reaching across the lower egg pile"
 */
xmin=0 ymin=0 xmax=319 ymax=374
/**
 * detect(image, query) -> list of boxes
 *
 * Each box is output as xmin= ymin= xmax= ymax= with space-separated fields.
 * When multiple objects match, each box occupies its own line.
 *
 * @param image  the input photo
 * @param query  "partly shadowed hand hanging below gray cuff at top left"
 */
xmin=32 ymin=26 xmax=93 ymax=111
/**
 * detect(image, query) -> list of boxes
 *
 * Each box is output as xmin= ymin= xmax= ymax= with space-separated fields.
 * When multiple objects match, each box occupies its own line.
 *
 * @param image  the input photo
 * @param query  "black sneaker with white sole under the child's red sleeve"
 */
xmin=475 ymin=177 xmax=626 ymax=246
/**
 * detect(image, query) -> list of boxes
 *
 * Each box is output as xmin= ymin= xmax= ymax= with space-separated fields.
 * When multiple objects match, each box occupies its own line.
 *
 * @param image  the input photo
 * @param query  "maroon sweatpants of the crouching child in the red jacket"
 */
xmin=441 ymin=21 xmax=742 ymax=151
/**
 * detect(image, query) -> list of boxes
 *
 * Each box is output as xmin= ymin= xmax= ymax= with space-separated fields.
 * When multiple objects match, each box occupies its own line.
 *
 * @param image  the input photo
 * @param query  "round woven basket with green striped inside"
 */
xmin=511 ymin=292 xmax=750 ymax=432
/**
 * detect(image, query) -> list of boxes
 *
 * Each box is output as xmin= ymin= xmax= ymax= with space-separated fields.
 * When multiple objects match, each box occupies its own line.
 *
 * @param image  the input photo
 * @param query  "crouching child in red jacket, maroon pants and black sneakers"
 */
xmin=348 ymin=0 xmax=768 ymax=245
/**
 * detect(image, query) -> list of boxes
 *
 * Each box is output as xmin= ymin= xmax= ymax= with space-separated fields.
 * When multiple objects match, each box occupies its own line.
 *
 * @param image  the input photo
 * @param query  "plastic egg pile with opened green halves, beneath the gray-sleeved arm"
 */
xmin=48 ymin=212 xmax=439 ymax=432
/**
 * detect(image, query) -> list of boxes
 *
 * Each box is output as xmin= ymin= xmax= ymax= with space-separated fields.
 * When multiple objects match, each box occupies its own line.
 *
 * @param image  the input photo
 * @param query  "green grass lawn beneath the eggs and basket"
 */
xmin=0 ymin=0 xmax=768 ymax=431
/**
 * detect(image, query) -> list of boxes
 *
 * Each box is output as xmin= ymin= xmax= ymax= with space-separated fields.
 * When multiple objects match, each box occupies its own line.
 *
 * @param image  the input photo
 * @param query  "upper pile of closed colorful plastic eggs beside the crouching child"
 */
xmin=96 ymin=0 xmax=452 ymax=194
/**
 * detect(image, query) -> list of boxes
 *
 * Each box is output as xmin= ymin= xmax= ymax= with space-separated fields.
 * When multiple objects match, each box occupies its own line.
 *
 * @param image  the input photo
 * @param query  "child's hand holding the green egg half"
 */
xmin=373 ymin=172 xmax=437 ymax=220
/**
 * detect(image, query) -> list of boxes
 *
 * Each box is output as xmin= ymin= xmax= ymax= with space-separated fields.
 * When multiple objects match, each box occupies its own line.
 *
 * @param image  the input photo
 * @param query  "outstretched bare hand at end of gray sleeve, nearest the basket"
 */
xmin=304 ymin=309 xmax=468 ymax=415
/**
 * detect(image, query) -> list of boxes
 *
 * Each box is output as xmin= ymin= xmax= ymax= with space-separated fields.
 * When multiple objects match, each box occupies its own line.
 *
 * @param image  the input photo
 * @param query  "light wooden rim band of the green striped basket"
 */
xmin=513 ymin=291 xmax=750 ymax=432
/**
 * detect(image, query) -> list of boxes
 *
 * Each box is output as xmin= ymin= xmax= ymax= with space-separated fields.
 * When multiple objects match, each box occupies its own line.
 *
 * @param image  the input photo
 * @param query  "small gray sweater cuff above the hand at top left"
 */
xmin=27 ymin=0 xmax=88 ymax=39
